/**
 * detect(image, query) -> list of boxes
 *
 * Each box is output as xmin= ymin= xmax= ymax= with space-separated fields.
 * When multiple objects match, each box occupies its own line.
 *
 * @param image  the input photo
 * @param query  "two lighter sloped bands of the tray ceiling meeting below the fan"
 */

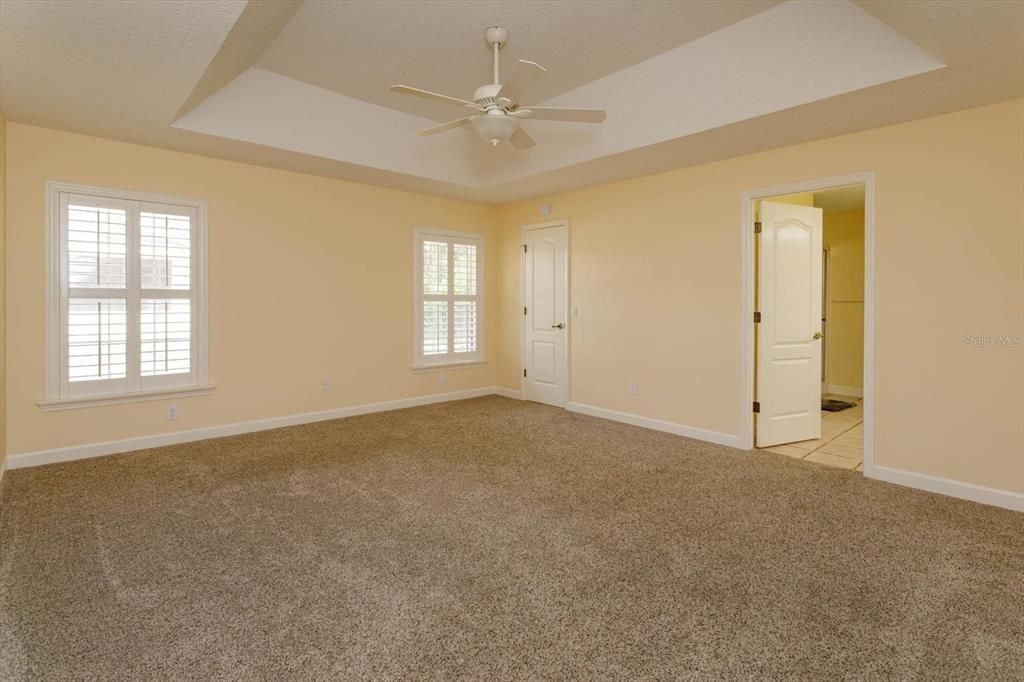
xmin=175 ymin=2 xmax=943 ymax=189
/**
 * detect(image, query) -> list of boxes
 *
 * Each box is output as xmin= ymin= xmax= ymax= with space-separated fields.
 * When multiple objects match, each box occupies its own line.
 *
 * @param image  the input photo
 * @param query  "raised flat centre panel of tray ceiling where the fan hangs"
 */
xmin=256 ymin=0 xmax=778 ymax=121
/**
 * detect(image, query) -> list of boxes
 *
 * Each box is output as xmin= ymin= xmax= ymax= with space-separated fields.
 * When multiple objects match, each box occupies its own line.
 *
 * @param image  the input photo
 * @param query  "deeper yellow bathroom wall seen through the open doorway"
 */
xmin=822 ymin=209 xmax=864 ymax=389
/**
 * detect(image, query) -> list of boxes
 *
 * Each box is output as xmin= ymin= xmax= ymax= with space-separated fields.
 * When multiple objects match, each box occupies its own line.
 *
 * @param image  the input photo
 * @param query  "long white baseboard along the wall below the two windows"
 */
xmin=6 ymin=386 xmax=498 ymax=469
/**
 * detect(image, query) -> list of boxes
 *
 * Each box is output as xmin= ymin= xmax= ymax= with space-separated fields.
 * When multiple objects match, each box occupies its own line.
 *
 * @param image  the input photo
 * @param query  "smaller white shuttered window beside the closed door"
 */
xmin=413 ymin=229 xmax=483 ymax=368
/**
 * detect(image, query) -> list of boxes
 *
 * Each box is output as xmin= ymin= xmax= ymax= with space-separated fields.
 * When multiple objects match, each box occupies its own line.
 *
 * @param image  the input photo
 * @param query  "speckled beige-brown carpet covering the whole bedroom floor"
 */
xmin=0 ymin=397 xmax=1024 ymax=681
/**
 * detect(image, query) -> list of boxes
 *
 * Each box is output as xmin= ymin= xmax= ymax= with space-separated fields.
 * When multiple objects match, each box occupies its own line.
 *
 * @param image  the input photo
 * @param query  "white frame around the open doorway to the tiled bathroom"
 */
xmin=739 ymin=171 xmax=876 ymax=478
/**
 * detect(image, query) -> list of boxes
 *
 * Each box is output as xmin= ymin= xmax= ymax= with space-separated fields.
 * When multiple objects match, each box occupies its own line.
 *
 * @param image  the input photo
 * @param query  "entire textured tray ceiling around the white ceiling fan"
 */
xmin=0 ymin=0 xmax=1024 ymax=203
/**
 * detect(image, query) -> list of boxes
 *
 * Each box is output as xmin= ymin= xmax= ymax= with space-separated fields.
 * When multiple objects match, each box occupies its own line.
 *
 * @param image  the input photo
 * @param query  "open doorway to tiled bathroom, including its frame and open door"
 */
xmin=741 ymin=174 xmax=873 ymax=476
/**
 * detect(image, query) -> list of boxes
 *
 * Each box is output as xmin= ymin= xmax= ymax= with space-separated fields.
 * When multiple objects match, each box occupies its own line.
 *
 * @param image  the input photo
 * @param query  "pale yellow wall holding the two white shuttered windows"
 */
xmin=6 ymin=123 xmax=501 ymax=454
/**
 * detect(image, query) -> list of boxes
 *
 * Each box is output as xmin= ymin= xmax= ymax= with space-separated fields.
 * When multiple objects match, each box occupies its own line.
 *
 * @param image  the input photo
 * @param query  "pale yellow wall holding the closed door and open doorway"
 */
xmin=499 ymin=99 xmax=1024 ymax=493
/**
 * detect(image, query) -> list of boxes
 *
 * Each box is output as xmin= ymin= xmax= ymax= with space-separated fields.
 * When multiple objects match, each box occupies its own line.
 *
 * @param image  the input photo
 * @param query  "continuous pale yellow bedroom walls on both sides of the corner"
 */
xmin=6 ymin=100 xmax=1024 ymax=492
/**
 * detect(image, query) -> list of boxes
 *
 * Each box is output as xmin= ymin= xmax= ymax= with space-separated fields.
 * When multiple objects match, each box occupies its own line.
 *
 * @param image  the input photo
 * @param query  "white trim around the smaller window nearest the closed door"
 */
xmin=413 ymin=226 xmax=487 ymax=371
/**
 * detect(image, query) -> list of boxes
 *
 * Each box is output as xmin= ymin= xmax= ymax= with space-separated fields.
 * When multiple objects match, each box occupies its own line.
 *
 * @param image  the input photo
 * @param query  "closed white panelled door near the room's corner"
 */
xmin=522 ymin=223 xmax=568 ymax=408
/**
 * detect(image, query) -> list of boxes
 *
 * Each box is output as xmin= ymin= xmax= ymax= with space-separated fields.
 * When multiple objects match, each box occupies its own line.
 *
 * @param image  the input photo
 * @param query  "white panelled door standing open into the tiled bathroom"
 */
xmin=756 ymin=202 xmax=822 ymax=447
